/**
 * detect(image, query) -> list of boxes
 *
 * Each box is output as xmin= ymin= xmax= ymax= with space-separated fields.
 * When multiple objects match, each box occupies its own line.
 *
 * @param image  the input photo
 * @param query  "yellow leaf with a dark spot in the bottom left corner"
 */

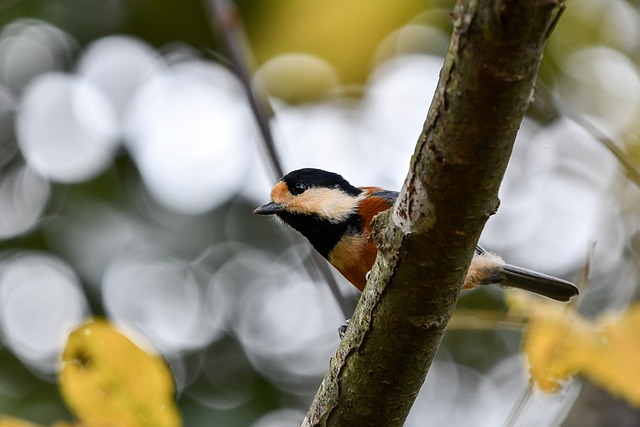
xmin=59 ymin=320 xmax=181 ymax=427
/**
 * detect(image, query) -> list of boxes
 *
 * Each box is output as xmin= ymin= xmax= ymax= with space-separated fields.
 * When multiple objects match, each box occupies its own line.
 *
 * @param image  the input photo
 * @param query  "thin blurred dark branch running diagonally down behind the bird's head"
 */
xmin=206 ymin=0 xmax=352 ymax=318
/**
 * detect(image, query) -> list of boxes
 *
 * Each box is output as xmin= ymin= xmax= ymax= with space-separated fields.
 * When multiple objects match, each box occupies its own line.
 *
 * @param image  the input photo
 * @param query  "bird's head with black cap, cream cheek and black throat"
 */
xmin=253 ymin=168 xmax=363 ymax=257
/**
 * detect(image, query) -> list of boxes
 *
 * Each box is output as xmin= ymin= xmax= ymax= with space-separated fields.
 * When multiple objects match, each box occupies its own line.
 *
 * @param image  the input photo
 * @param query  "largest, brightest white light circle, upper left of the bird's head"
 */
xmin=125 ymin=62 xmax=255 ymax=214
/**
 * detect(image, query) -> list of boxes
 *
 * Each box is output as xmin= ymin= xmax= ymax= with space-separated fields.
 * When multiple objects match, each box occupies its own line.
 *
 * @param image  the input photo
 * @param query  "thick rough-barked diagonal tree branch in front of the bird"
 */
xmin=303 ymin=0 xmax=564 ymax=427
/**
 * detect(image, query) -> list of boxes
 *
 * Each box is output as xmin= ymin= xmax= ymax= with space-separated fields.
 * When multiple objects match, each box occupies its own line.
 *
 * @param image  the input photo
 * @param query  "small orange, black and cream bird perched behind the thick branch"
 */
xmin=253 ymin=168 xmax=578 ymax=301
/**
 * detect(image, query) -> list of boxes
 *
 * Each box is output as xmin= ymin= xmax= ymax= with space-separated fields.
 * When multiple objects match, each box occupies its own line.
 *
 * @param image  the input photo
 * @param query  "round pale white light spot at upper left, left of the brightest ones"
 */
xmin=17 ymin=73 xmax=119 ymax=182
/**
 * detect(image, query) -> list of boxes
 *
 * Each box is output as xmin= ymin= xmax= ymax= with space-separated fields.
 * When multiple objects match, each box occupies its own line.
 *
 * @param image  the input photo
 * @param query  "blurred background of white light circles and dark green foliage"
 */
xmin=0 ymin=0 xmax=640 ymax=427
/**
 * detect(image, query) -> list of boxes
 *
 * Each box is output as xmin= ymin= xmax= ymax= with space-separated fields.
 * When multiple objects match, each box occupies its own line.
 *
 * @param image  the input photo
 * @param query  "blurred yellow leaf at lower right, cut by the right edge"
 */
xmin=524 ymin=302 xmax=640 ymax=406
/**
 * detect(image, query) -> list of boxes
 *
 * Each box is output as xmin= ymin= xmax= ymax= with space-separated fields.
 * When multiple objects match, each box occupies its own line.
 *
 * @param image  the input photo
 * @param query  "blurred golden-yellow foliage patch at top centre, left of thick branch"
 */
xmin=239 ymin=0 xmax=444 ymax=84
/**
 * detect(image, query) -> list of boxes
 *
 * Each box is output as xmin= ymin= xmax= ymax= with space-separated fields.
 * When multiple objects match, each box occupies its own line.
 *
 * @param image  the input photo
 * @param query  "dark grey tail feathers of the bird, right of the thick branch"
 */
xmin=500 ymin=264 xmax=578 ymax=301
